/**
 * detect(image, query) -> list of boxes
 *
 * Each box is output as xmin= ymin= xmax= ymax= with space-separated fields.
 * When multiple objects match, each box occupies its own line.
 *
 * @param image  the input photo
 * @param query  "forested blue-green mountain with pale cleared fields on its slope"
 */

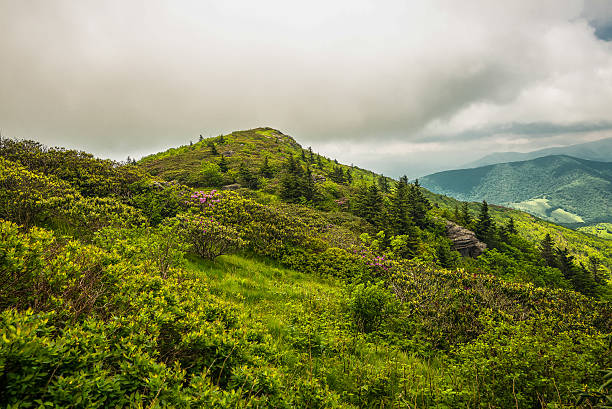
xmin=419 ymin=155 xmax=612 ymax=227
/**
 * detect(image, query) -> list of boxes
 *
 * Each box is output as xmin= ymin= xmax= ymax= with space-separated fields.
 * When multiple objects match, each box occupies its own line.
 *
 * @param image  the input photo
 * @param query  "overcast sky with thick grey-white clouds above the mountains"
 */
xmin=0 ymin=0 xmax=612 ymax=177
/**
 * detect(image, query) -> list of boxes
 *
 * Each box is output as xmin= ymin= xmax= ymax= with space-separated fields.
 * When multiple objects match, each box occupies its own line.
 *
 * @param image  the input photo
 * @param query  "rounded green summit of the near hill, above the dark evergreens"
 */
xmin=138 ymin=128 xmax=391 ymax=209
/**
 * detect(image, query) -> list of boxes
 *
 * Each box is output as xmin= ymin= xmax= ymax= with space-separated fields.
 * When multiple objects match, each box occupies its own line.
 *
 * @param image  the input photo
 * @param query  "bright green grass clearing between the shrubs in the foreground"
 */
xmin=187 ymin=255 xmax=462 ymax=407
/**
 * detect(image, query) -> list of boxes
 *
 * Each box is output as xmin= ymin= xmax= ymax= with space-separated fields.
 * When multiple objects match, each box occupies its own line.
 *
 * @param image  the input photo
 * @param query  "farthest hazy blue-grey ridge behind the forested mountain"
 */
xmin=463 ymin=138 xmax=612 ymax=168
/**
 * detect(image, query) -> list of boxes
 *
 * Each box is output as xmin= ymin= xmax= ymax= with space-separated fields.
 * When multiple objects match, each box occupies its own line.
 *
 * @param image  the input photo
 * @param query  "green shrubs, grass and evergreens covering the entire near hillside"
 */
xmin=0 ymin=128 xmax=612 ymax=408
